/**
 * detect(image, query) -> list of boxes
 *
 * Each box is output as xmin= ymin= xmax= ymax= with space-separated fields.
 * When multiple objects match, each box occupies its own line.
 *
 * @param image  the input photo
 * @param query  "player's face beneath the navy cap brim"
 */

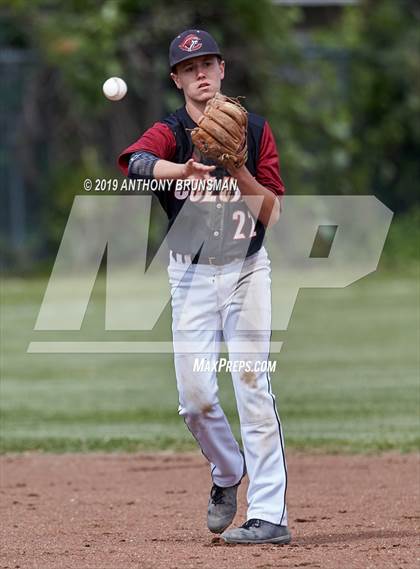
xmin=171 ymin=55 xmax=225 ymax=103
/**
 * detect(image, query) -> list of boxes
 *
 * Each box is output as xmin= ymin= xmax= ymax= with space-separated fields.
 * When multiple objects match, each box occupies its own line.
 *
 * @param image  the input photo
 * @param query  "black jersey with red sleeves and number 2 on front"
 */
xmin=118 ymin=107 xmax=285 ymax=260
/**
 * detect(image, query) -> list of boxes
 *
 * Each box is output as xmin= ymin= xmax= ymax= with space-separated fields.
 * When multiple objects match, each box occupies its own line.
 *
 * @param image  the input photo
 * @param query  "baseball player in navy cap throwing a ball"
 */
xmin=119 ymin=30 xmax=291 ymax=544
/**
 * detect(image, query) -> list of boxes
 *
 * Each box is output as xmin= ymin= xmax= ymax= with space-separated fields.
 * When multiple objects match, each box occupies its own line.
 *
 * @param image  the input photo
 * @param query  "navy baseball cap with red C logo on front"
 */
xmin=169 ymin=30 xmax=222 ymax=69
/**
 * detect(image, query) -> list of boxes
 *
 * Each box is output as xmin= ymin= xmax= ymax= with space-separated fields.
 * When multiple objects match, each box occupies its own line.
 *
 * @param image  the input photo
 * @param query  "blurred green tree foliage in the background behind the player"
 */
xmin=2 ymin=0 xmax=420 ymax=262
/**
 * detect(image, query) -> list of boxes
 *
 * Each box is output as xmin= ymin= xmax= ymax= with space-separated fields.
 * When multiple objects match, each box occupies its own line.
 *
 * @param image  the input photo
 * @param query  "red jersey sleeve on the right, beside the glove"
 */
xmin=255 ymin=121 xmax=286 ymax=196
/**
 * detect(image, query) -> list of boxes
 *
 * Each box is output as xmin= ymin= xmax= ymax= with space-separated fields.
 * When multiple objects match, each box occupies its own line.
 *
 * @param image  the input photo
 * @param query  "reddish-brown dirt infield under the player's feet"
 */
xmin=0 ymin=453 xmax=419 ymax=569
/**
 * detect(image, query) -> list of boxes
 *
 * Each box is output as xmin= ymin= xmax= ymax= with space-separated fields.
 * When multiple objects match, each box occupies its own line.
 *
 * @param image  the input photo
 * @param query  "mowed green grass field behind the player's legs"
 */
xmin=1 ymin=264 xmax=419 ymax=452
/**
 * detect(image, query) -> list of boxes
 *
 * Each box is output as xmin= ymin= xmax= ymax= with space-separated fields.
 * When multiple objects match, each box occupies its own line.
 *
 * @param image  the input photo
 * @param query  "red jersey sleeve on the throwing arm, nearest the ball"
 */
xmin=118 ymin=122 xmax=176 ymax=176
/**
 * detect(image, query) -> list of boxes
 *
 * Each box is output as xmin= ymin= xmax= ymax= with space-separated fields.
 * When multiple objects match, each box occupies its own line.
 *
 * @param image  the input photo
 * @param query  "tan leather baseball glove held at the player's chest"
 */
xmin=191 ymin=93 xmax=248 ymax=169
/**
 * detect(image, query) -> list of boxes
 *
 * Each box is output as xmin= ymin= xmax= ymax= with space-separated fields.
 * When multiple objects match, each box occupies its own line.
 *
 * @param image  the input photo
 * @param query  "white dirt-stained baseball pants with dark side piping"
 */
xmin=168 ymin=247 xmax=287 ymax=525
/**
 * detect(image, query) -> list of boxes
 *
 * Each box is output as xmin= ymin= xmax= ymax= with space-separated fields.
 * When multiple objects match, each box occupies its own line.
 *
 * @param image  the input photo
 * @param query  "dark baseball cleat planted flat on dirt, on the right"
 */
xmin=220 ymin=518 xmax=292 ymax=545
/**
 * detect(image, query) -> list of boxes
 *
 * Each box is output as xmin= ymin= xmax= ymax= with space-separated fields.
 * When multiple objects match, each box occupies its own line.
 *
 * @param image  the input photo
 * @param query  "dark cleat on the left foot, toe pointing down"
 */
xmin=207 ymin=451 xmax=246 ymax=533
